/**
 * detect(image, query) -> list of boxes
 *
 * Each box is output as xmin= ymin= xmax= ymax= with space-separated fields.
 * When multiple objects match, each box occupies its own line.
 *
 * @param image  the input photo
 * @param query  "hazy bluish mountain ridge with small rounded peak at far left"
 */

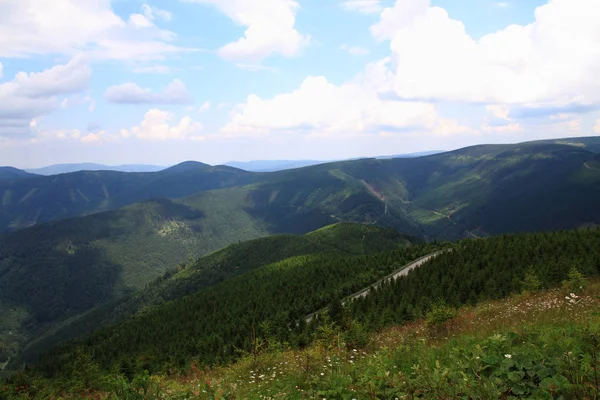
xmin=0 ymin=163 xmax=255 ymax=232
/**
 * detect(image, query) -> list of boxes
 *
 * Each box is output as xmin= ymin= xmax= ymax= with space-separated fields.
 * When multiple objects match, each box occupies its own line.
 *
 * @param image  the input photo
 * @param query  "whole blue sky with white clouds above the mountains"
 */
xmin=0 ymin=0 xmax=600 ymax=168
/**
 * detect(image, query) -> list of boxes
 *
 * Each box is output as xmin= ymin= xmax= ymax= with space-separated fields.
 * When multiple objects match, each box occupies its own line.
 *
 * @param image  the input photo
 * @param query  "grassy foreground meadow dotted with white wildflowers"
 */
xmin=7 ymin=280 xmax=600 ymax=400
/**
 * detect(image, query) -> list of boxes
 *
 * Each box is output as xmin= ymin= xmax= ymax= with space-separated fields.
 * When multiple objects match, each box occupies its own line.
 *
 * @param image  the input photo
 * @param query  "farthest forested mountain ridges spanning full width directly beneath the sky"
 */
xmin=0 ymin=137 xmax=600 ymax=239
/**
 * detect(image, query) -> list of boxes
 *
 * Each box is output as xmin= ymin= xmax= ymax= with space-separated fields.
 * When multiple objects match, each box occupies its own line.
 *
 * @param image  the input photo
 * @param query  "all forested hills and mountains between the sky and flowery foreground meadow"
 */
xmin=0 ymin=138 xmax=600 ymax=396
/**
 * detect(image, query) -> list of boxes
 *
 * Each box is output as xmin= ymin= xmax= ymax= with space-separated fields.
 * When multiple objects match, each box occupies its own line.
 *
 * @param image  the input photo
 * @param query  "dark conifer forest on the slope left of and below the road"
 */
xmin=32 ymin=245 xmax=435 ymax=375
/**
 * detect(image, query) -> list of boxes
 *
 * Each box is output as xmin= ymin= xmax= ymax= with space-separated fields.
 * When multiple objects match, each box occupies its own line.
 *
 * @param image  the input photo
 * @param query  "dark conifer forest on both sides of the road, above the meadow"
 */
xmin=30 ymin=229 xmax=600 ymax=380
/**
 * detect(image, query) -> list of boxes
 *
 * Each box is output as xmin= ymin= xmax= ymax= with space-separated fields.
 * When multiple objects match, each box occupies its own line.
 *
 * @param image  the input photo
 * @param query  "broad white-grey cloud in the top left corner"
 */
xmin=0 ymin=0 xmax=186 ymax=60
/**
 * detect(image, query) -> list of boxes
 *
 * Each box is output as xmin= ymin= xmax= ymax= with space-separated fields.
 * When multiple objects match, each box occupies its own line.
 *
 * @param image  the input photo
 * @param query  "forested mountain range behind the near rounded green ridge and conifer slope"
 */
xmin=0 ymin=138 xmax=600 ymax=376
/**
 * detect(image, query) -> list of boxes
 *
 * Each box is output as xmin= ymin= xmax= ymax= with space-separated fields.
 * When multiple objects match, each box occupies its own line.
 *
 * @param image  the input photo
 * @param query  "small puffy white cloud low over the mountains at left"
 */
xmin=121 ymin=109 xmax=202 ymax=140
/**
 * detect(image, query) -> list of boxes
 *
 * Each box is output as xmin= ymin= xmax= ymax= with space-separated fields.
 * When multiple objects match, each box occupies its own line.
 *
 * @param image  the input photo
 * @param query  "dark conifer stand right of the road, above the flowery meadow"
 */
xmin=349 ymin=229 xmax=600 ymax=329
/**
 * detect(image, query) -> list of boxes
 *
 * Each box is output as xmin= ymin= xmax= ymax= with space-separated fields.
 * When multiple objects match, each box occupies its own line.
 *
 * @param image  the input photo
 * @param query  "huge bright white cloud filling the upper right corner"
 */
xmin=371 ymin=0 xmax=600 ymax=112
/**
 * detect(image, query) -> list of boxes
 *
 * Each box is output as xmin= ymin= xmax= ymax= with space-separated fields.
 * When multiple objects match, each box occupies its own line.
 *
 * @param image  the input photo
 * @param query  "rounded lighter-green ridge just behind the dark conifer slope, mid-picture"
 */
xmin=17 ymin=223 xmax=414 ymax=359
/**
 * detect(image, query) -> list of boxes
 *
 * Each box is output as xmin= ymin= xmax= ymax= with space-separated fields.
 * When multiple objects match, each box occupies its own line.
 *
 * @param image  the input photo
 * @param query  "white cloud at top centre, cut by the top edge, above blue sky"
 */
xmin=182 ymin=0 xmax=310 ymax=62
